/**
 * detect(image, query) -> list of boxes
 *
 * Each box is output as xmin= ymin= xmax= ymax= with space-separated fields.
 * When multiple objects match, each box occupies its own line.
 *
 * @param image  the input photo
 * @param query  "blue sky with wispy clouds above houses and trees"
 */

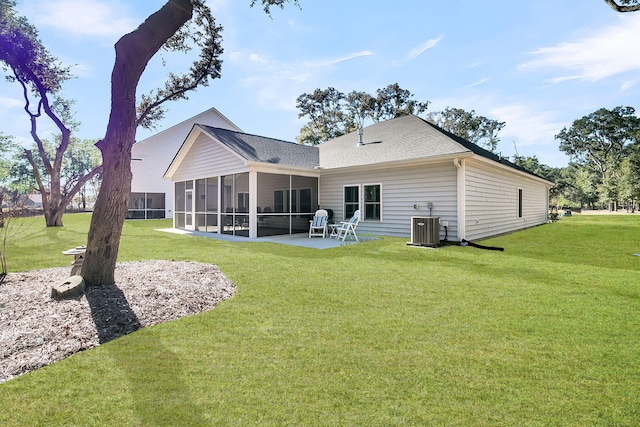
xmin=0 ymin=0 xmax=640 ymax=167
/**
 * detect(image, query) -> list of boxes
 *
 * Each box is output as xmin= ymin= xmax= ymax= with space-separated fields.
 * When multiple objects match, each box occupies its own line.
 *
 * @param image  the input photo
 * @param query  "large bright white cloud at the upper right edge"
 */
xmin=518 ymin=15 xmax=640 ymax=83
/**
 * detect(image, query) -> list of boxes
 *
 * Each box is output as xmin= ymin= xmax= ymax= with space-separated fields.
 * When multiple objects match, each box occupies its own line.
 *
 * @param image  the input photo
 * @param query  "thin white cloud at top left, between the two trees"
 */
xmin=25 ymin=0 xmax=140 ymax=37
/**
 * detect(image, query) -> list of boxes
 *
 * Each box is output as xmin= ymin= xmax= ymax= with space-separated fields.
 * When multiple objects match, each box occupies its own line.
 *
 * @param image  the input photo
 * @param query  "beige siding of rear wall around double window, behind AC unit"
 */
xmin=319 ymin=162 xmax=457 ymax=240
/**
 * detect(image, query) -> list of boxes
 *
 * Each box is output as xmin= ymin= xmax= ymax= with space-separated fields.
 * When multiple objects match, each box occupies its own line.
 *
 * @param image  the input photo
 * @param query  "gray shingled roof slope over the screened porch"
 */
xmin=199 ymin=125 xmax=318 ymax=169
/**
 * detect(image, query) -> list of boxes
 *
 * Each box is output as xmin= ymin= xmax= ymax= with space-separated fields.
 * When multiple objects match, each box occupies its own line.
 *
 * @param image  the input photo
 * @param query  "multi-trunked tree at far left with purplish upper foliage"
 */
xmin=0 ymin=0 xmax=101 ymax=226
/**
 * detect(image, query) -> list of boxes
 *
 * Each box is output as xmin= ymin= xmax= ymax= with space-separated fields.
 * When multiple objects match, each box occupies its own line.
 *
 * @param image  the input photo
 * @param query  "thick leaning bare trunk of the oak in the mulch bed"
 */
xmin=81 ymin=0 xmax=193 ymax=285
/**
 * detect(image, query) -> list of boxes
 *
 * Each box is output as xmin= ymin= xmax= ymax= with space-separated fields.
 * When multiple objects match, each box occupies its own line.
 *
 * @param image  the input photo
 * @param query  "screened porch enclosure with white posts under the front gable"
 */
xmin=174 ymin=171 xmax=318 ymax=238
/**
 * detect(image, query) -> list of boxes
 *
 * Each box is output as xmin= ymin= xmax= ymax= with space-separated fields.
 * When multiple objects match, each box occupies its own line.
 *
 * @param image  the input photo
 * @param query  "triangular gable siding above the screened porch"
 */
xmin=172 ymin=134 xmax=249 ymax=181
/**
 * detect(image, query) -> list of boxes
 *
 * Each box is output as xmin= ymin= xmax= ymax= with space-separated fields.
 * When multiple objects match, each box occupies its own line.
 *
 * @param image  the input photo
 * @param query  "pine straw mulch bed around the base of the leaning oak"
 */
xmin=0 ymin=261 xmax=236 ymax=383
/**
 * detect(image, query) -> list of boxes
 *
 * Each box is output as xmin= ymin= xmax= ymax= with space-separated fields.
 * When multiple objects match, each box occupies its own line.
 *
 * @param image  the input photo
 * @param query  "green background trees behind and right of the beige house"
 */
xmin=296 ymin=83 xmax=640 ymax=211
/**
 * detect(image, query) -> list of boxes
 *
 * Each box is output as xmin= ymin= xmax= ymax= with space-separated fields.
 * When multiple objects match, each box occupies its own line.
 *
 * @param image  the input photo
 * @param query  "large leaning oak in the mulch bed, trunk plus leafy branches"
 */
xmin=81 ymin=0 xmax=297 ymax=285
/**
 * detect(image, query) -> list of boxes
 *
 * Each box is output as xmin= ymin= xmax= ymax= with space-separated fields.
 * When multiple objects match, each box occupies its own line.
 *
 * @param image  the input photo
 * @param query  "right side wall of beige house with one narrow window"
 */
xmin=465 ymin=160 xmax=547 ymax=240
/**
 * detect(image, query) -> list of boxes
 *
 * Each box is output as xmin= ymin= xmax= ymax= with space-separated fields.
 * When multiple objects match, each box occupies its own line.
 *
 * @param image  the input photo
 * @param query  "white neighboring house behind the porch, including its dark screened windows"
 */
xmin=127 ymin=108 xmax=240 ymax=219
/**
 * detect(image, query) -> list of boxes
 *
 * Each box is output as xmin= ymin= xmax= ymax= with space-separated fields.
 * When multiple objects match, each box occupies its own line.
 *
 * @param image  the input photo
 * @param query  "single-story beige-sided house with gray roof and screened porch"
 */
xmin=165 ymin=115 xmax=553 ymax=240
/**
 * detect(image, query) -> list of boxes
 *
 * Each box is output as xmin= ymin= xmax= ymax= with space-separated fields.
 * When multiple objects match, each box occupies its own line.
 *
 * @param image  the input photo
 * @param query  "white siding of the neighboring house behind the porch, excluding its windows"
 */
xmin=131 ymin=109 xmax=240 ymax=218
